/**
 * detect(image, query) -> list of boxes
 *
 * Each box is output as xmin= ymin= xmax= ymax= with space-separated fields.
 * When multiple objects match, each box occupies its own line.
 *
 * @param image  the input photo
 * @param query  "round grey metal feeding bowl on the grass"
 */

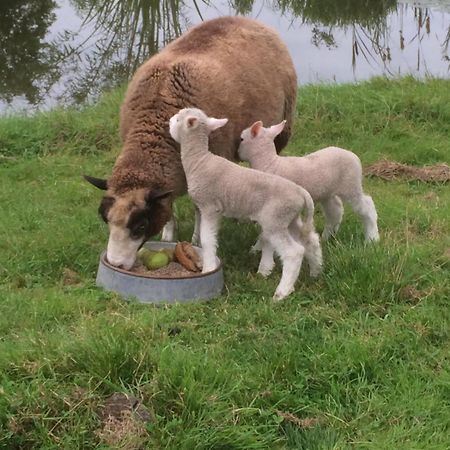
xmin=97 ymin=241 xmax=223 ymax=303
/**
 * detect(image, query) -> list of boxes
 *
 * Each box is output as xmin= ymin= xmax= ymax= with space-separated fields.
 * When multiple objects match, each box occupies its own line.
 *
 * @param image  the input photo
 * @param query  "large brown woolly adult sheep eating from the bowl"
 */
xmin=85 ymin=17 xmax=297 ymax=269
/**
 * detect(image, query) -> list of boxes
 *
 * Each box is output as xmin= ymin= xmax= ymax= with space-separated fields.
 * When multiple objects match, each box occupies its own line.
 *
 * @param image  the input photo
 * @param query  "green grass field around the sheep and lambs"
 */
xmin=0 ymin=78 xmax=450 ymax=450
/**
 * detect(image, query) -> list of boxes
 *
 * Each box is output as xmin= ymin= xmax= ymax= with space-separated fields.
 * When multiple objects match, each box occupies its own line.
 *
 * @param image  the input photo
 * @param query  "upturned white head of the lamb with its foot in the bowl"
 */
xmin=169 ymin=108 xmax=228 ymax=143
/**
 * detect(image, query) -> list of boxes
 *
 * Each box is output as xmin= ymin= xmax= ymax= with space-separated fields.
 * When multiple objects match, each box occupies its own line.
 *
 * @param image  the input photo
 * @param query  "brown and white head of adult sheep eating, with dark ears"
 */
xmin=85 ymin=176 xmax=172 ymax=270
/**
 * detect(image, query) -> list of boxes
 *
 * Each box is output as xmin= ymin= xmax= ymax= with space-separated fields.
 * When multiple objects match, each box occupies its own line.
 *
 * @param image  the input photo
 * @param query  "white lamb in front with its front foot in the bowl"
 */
xmin=169 ymin=108 xmax=322 ymax=300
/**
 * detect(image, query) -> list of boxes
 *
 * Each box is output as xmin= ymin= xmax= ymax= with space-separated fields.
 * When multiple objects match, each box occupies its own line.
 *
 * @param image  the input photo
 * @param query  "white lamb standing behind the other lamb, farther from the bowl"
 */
xmin=238 ymin=121 xmax=379 ymax=243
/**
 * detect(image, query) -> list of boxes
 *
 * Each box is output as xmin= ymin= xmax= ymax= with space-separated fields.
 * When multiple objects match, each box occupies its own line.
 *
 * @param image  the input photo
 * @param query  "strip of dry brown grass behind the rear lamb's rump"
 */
xmin=364 ymin=160 xmax=450 ymax=183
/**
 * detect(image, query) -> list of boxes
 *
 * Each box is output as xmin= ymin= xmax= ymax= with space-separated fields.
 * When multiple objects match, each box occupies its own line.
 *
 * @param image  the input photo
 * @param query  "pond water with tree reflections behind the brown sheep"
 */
xmin=0 ymin=0 xmax=450 ymax=114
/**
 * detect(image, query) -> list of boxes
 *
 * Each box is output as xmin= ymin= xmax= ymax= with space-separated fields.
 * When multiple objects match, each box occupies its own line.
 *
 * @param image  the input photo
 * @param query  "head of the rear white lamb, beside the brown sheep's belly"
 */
xmin=238 ymin=120 xmax=286 ymax=162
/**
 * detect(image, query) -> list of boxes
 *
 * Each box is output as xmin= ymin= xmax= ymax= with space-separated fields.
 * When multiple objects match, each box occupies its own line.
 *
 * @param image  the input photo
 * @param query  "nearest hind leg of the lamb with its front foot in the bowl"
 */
xmin=267 ymin=230 xmax=305 ymax=301
